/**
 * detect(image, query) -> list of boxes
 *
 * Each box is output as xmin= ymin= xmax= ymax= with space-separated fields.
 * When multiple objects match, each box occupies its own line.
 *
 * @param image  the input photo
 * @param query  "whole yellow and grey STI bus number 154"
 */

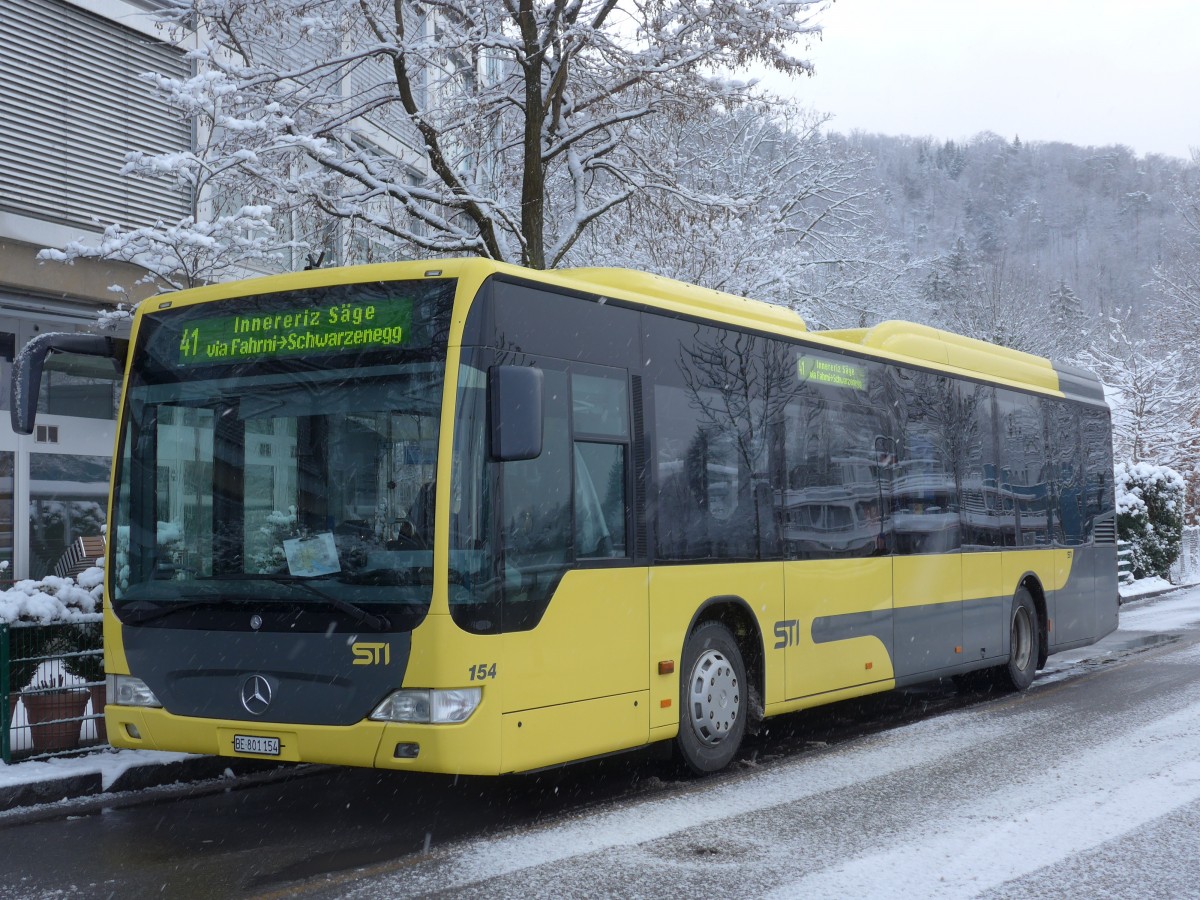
xmin=13 ymin=259 xmax=1118 ymax=774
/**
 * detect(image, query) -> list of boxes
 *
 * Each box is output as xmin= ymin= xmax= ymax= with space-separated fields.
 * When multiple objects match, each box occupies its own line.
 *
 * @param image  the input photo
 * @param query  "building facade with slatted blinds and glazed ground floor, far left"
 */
xmin=0 ymin=0 xmax=192 ymax=580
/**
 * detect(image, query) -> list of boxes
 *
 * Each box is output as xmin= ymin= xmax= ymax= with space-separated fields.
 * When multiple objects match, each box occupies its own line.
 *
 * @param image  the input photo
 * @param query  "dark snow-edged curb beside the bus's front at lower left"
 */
xmin=0 ymin=756 xmax=290 ymax=812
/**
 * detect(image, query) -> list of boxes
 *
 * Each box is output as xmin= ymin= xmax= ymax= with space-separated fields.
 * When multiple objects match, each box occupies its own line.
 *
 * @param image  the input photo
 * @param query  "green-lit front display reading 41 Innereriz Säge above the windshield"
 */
xmin=175 ymin=298 xmax=413 ymax=366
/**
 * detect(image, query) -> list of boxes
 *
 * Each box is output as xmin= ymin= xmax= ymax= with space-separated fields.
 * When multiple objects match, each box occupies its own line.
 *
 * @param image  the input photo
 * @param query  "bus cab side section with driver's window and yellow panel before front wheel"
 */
xmin=500 ymin=364 xmax=649 ymax=772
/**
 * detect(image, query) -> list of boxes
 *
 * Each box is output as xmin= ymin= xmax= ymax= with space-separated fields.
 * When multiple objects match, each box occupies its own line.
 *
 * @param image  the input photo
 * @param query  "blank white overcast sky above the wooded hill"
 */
xmin=773 ymin=0 xmax=1200 ymax=158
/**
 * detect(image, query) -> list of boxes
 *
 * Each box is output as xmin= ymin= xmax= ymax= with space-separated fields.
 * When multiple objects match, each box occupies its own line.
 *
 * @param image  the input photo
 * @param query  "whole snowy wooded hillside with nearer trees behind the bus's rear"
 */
xmin=812 ymin=133 xmax=1200 ymax=508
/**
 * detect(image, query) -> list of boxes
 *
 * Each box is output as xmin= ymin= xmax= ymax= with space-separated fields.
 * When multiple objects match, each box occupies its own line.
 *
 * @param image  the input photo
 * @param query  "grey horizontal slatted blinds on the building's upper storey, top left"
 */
xmin=0 ymin=0 xmax=191 ymax=228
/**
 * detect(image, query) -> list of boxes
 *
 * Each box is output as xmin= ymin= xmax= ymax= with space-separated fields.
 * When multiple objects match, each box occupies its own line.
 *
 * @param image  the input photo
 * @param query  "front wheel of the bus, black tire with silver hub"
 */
xmin=676 ymin=622 xmax=750 ymax=775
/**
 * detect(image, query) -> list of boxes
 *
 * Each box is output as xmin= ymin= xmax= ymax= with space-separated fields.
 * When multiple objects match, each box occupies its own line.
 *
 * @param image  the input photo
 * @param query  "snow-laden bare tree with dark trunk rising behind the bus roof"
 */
xmin=46 ymin=0 xmax=820 ymax=288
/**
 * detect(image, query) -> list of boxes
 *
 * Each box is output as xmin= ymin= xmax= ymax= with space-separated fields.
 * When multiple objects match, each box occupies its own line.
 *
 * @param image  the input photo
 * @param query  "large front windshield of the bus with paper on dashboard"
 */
xmin=110 ymin=282 xmax=452 ymax=631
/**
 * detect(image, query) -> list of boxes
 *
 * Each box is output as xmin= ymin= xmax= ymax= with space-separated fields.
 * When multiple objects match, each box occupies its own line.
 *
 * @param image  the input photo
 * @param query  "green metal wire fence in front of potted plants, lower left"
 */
xmin=0 ymin=616 xmax=108 ymax=763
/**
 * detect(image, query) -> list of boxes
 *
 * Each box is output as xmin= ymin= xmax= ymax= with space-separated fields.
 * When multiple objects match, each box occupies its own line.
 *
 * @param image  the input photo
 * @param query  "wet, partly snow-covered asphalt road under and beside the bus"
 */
xmin=0 ymin=602 xmax=1200 ymax=898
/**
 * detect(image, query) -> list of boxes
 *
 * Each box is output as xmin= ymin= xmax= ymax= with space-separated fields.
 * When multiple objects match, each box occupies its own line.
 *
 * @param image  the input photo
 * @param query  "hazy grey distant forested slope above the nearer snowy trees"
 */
xmin=846 ymin=133 xmax=1196 ymax=356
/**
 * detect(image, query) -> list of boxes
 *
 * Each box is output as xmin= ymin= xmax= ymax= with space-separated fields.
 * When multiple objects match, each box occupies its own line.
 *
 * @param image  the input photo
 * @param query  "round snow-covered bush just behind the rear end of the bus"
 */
xmin=1114 ymin=462 xmax=1187 ymax=578
